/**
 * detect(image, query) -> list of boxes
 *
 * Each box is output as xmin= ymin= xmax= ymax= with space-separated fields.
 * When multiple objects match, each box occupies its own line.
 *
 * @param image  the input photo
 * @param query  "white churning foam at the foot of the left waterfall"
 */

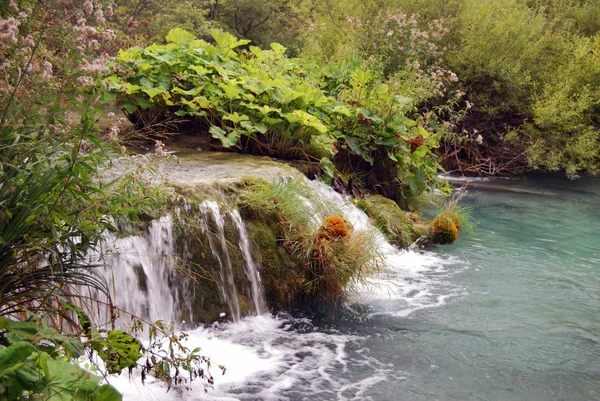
xmin=110 ymin=314 xmax=397 ymax=401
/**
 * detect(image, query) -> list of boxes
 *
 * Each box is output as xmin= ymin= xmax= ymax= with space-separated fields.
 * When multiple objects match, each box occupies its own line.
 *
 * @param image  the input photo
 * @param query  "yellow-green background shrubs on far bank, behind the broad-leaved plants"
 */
xmin=68 ymin=0 xmax=600 ymax=176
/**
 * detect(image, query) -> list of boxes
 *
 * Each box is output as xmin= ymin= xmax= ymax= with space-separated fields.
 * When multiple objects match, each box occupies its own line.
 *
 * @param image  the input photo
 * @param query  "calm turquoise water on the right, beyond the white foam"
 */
xmin=345 ymin=176 xmax=600 ymax=401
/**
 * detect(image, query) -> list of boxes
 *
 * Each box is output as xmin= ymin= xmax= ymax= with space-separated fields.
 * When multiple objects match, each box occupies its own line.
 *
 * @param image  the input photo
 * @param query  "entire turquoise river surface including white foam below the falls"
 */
xmin=113 ymin=175 xmax=600 ymax=401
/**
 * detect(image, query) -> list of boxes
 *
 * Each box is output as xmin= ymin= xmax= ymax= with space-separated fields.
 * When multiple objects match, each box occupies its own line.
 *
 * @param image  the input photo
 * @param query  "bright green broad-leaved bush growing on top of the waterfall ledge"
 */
xmin=104 ymin=29 xmax=450 ymax=199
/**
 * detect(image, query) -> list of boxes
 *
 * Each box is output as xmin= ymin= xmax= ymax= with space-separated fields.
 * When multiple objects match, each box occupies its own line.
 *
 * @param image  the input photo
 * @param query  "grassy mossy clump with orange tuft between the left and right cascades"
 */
xmin=239 ymin=178 xmax=381 ymax=306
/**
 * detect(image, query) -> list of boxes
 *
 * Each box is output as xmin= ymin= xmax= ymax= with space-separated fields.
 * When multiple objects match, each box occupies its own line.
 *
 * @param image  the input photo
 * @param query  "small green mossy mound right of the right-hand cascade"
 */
xmin=356 ymin=195 xmax=420 ymax=248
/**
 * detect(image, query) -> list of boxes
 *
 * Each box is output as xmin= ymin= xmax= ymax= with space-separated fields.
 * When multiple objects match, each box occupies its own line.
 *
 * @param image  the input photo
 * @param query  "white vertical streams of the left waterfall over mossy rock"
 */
xmin=93 ymin=201 xmax=268 ymax=325
